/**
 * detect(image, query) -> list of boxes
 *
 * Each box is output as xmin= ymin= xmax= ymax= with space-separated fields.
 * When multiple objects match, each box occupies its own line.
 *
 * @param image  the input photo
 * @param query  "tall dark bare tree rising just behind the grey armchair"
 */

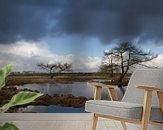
xmin=101 ymin=42 xmax=157 ymax=88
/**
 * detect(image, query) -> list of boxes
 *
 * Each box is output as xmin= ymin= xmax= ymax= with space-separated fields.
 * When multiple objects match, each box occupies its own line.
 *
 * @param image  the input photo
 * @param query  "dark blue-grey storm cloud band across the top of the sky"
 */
xmin=0 ymin=0 xmax=163 ymax=43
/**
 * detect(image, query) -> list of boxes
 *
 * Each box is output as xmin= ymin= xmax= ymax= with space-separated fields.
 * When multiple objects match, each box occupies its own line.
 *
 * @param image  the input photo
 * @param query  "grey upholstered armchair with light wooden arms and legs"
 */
xmin=85 ymin=69 xmax=163 ymax=130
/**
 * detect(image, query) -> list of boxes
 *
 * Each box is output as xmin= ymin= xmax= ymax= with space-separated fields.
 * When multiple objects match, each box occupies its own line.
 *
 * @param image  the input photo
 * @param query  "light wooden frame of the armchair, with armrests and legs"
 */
xmin=88 ymin=82 xmax=163 ymax=130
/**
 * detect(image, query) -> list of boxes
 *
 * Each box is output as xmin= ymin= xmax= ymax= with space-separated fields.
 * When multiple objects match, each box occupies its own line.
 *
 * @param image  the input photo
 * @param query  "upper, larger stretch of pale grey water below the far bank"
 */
xmin=17 ymin=82 xmax=108 ymax=99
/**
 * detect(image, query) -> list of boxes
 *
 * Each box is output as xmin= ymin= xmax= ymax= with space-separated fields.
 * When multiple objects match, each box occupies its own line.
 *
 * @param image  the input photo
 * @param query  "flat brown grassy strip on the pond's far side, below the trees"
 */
xmin=7 ymin=73 xmax=130 ymax=85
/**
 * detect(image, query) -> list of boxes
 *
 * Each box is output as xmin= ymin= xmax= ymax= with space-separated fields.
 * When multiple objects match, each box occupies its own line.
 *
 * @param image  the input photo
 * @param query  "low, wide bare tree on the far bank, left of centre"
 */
xmin=37 ymin=63 xmax=72 ymax=78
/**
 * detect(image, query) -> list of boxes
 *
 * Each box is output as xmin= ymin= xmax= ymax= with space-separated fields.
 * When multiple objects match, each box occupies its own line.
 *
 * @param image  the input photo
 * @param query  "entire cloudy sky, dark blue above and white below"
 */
xmin=0 ymin=0 xmax=163 ymax=71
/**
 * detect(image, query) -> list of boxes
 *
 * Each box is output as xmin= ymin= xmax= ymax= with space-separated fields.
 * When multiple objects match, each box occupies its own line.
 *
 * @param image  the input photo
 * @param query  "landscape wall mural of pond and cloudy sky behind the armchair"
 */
xmin=0 ymin=0 xmax=163 ymax=130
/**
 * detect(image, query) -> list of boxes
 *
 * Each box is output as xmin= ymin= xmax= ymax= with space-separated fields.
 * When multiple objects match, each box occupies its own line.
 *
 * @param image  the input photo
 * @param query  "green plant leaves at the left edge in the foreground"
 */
xmin=0 ymin=64 xmax=43 ymax=130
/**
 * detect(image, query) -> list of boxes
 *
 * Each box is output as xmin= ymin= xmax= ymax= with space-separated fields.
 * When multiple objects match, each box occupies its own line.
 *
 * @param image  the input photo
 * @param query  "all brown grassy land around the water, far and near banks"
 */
xmin=0 ymin=73 xmax=130 ymax=113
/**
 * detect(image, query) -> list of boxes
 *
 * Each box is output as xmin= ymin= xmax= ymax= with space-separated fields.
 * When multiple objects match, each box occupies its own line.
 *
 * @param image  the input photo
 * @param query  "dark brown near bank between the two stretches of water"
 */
xmin=0 ymin=87 xmax=92 ymax=113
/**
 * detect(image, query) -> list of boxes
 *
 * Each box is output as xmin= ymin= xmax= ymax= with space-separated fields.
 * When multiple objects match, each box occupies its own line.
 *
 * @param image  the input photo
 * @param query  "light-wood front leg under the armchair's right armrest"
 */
xmin=141 ymin=91 xmax=152 ymax=130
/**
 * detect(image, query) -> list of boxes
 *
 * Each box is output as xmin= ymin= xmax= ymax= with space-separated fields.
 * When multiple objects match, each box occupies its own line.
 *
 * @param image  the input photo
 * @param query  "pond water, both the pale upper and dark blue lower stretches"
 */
xmin=17 ymin=82 xmax=122 ymax=113
